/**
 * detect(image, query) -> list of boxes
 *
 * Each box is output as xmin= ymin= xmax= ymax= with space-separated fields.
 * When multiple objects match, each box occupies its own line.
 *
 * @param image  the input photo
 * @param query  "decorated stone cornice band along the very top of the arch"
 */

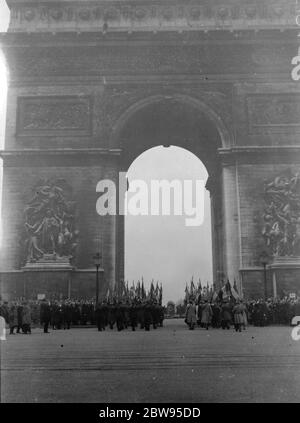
xmin=7 ymin=0 xmax=296 ymax=32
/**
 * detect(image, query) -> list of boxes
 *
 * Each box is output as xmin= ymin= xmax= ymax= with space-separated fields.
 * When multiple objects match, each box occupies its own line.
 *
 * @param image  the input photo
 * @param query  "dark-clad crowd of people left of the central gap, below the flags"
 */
xmin=0 ymin=299 xmax=164 ymax=334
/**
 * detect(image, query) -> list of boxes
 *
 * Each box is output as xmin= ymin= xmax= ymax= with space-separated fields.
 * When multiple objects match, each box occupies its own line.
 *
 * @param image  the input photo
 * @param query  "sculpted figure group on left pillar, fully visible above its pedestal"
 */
xmin=24 ymin=183 xmax=79 ymax=261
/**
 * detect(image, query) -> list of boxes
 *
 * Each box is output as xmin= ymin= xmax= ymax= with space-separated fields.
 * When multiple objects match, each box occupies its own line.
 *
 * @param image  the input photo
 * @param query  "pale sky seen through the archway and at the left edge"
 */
xmin=0 ymin=4 xmax=212 ymax=303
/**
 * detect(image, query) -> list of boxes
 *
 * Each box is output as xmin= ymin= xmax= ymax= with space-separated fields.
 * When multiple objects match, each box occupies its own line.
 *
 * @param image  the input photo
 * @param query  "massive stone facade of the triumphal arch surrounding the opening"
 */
xmin=1 ymin=0 xmax=300 ymax=297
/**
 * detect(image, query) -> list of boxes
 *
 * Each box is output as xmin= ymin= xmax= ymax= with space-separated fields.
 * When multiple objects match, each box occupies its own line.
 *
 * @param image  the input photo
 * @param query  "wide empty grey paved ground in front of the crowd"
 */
xmin=1 ymin=320 xmax=300 ymax=403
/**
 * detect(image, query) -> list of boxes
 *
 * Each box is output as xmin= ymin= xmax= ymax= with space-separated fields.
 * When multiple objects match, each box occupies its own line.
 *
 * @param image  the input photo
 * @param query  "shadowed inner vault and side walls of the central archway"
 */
xmin=115 ymin=95 xmax=228 ymax=294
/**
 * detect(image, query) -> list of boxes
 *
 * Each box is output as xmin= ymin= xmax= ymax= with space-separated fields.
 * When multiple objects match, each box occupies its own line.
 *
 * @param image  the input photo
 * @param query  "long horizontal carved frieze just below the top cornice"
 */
xmin=7 ymin=39 xmax=293 ymax=78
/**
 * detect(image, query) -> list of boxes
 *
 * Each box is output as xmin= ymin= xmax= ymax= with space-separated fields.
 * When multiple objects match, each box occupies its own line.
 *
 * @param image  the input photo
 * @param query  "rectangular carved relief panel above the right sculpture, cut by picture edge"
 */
xmin=247 ymin=94 xmax=300 ymax=134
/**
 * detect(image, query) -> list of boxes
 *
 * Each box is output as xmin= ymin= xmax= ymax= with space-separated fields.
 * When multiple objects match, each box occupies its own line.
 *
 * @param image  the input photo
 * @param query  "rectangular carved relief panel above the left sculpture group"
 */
xmin=17 ymin=96 xmax=91 ymax=136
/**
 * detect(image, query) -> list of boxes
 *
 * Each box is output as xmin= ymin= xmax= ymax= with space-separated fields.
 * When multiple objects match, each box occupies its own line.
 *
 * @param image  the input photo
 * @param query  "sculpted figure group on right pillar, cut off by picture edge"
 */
xmin=262 ymin=173 xmax=300 ymax=256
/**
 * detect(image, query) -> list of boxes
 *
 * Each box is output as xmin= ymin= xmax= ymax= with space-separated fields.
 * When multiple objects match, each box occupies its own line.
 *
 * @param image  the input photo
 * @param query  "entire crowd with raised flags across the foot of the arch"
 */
xmin=0 ymin=281 xmax=300 ymax=334
